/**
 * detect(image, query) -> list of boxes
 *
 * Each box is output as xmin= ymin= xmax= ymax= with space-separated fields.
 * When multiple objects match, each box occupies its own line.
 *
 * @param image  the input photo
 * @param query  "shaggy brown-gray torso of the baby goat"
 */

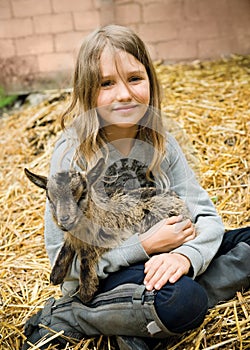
xmin=83 ymin=188 xmax=190 ymax=239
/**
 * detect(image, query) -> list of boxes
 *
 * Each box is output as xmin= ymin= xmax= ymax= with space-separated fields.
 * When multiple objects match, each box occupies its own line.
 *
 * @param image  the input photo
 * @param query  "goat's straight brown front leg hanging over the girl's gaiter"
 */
xmin=79 ymin=247 xmax=99 ymax=303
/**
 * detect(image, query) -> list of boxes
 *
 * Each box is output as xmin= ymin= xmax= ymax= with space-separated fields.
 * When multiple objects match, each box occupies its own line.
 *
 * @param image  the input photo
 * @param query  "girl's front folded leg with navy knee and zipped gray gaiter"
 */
xmin=24 ymin=264 xmax=207 ymax=350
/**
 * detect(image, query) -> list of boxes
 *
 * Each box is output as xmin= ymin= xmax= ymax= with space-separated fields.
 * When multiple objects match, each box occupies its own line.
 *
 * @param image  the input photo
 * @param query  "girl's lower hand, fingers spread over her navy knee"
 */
xmin=144 ymin=253 xmax=191 ymax=290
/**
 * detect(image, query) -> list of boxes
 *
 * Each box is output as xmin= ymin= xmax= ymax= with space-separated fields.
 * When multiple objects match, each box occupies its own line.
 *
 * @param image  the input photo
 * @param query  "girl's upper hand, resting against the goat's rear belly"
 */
xmin=140 ymin=216 xmax=196 ymax=255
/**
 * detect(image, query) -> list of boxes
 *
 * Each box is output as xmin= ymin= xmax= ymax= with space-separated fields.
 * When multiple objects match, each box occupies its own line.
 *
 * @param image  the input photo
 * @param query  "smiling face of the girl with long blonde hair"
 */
xmin=97 ymin=49 xmax=150 ymax=128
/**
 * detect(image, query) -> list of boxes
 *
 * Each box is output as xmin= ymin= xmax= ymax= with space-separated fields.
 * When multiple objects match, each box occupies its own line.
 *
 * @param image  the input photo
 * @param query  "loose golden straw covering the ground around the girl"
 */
xmin=0 ymin=56 xmax=250 ymax=350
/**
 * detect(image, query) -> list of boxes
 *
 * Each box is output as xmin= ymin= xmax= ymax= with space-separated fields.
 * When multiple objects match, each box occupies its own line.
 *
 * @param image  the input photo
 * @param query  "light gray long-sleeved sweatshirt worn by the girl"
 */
xmin=45 ymin=133 xmax=224 ymax=294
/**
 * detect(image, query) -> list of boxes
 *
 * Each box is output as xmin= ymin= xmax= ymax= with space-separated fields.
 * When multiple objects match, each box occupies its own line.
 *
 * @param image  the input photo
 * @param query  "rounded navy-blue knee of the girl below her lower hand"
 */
xmin=155 ymin=276 xmax=208 ymax=333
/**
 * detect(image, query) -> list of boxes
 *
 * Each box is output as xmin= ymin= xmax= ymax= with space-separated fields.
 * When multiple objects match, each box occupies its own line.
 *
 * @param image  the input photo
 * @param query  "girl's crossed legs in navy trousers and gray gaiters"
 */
xmin=23 ymin=228 xmax=250 ymax=349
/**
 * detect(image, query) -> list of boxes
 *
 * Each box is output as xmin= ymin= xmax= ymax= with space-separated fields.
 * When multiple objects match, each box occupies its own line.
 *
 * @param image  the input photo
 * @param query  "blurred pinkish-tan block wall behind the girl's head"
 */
xmin=0 ymin=0 xmax=250 ymax=91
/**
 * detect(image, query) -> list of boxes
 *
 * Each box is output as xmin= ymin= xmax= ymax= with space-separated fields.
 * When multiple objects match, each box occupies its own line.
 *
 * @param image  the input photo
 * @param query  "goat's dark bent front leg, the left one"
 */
xmin=50 ymin=240 xmax=75 ymax=285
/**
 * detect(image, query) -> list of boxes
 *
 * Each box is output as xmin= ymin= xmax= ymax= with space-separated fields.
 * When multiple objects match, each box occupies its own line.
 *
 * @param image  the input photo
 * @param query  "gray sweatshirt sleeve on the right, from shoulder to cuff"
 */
xmin=165 ymin=134 xmax=224 ymax=278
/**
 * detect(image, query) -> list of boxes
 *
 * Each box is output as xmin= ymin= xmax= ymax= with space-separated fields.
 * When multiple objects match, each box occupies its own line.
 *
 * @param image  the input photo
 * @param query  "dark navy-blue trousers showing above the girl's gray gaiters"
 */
xmin=100 ymin=227 xmax=250 ymax=333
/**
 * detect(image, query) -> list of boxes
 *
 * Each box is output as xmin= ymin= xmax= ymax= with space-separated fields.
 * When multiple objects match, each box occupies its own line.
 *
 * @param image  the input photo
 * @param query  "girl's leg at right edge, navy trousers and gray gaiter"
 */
xmin=196 ymin=227 xmax=250 ymax=308
